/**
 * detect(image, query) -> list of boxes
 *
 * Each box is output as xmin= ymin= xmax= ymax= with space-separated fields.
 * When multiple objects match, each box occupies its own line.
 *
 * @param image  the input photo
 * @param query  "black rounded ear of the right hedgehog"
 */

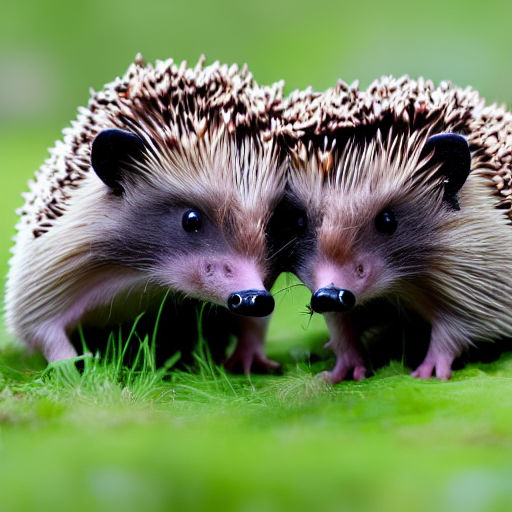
xmin=420 ymin=133 xmax=471 ymax=210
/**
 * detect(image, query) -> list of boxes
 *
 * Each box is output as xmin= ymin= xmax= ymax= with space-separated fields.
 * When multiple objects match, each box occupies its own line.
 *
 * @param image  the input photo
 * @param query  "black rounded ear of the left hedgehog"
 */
xmin=91 ymin=130 xmax=145 ymax=196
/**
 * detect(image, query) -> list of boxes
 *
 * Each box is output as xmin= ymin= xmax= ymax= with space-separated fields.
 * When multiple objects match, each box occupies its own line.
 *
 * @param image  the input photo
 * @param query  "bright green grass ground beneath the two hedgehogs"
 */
xmin=0 ymin=332 xmax=512 ymax=511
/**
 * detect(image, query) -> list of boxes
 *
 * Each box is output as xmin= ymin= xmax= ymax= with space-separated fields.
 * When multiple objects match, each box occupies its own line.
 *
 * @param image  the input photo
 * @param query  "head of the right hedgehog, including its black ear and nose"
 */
xmin=290 ymin=132 xmax=471 ymax=313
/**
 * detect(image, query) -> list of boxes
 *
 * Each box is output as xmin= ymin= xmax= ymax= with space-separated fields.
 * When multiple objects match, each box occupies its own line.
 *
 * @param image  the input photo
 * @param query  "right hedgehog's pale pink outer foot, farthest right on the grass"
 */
xmin=411 ymin=321 xmax=460 ymax=380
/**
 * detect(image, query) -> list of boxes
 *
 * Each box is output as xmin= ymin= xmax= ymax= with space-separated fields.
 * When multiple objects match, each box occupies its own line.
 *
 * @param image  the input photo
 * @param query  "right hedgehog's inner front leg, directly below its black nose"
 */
xmin=322 ymin=313 xmax=366 ymax=384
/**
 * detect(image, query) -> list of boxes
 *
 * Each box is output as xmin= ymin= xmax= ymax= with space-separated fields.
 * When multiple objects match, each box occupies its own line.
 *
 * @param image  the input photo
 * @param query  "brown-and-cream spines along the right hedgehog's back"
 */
xmin=280 ymin=76 xmax=512 ymax=217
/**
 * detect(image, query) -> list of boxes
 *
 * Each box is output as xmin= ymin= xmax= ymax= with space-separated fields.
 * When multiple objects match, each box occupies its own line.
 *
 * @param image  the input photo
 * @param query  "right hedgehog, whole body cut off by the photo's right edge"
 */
xmin=282 ymin=76 xmax=512 ymax=383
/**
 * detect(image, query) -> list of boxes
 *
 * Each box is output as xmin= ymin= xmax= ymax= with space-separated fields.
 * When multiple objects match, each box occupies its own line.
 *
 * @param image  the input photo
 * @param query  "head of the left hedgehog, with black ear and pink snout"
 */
xmin=91 ymin=129 xmax=284 ymax=316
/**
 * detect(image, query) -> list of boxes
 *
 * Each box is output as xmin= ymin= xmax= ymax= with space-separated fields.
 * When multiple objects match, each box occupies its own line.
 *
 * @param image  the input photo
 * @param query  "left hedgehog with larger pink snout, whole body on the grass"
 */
xmin=5 ymin=55 xmax=285 ymax=372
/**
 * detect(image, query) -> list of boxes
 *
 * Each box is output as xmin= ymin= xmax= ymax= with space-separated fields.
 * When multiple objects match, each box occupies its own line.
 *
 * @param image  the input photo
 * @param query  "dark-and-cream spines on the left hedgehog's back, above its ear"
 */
xmin=19 ymin=54 xmax=283 ymax=236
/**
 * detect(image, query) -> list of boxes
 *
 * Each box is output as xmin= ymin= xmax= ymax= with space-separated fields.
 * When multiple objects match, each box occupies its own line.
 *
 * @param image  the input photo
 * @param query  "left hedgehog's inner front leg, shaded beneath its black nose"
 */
xmin=224 ymin=316 xmax=280 ymax=374
